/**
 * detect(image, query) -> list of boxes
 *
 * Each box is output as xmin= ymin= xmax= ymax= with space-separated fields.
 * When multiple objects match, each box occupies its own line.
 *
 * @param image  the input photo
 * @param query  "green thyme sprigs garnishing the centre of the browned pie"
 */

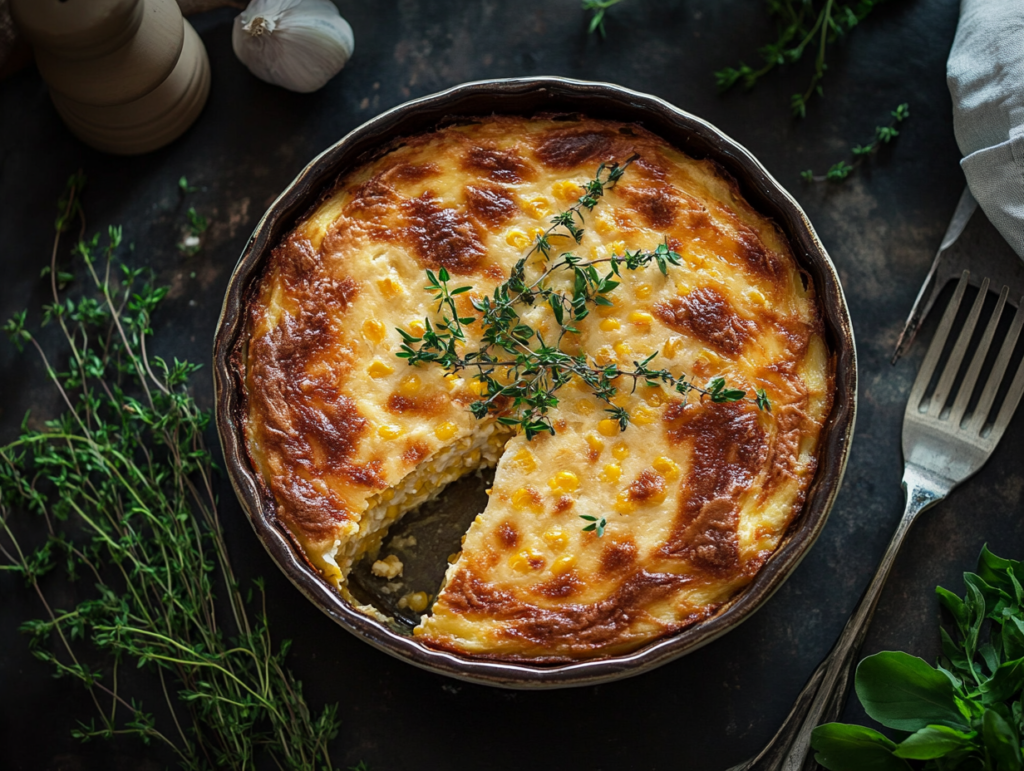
xmin=395 ymin=156 xmax=771 ymax=439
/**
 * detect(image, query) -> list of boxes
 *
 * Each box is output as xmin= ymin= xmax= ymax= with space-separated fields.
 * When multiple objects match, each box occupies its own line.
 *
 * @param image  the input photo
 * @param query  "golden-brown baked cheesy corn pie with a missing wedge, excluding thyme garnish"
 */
xmin=245 ymin=117 xmax=833 ymax=660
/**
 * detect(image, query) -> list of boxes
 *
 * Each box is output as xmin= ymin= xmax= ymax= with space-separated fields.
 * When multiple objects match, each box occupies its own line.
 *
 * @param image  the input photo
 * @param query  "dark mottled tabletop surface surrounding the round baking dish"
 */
xmin=0 ymin=0 xmax=1024 ymax=771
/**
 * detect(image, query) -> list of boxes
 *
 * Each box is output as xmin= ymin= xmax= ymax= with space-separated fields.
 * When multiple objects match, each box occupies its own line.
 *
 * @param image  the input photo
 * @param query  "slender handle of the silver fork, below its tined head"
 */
xmin=730 ymin=464 xmax=952 ymax=771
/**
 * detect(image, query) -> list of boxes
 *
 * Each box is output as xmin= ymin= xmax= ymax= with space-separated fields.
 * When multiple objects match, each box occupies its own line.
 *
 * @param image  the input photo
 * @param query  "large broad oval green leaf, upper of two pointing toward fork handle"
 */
xmin=856 ymin=651 xmax=968 ymax=731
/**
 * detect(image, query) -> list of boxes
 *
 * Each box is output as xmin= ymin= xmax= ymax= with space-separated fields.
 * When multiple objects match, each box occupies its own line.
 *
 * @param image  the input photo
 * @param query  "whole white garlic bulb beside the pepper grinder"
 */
xmin=231 ymin=0 xmax=355 ymax=93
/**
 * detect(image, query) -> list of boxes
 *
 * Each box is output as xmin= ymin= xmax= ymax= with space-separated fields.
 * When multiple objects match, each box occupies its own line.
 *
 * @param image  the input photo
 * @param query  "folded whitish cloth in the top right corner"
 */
xmin=946 ymin=0 xmax=1024 ymax=257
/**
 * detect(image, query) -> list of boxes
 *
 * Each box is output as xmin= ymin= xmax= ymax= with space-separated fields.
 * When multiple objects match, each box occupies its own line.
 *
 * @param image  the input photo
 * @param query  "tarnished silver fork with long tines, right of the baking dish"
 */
xmin=730 ymin=270 xmax=1024 ymax=771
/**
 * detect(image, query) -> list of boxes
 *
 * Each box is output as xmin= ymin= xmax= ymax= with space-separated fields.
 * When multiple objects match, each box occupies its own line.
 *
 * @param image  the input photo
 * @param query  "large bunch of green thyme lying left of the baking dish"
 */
xmin=0 ymin=175 xmax=338 ymax=771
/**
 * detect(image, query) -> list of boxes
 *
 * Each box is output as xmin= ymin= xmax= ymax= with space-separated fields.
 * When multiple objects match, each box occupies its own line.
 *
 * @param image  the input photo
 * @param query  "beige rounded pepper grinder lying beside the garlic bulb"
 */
xmin=11 ymin=0 xmax=210 ymax=155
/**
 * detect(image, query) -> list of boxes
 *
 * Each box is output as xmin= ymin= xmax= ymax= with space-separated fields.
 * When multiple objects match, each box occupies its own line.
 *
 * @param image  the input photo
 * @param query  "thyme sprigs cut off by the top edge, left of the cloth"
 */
xmin=715 ymin=0 xmax=884 ymax=118
